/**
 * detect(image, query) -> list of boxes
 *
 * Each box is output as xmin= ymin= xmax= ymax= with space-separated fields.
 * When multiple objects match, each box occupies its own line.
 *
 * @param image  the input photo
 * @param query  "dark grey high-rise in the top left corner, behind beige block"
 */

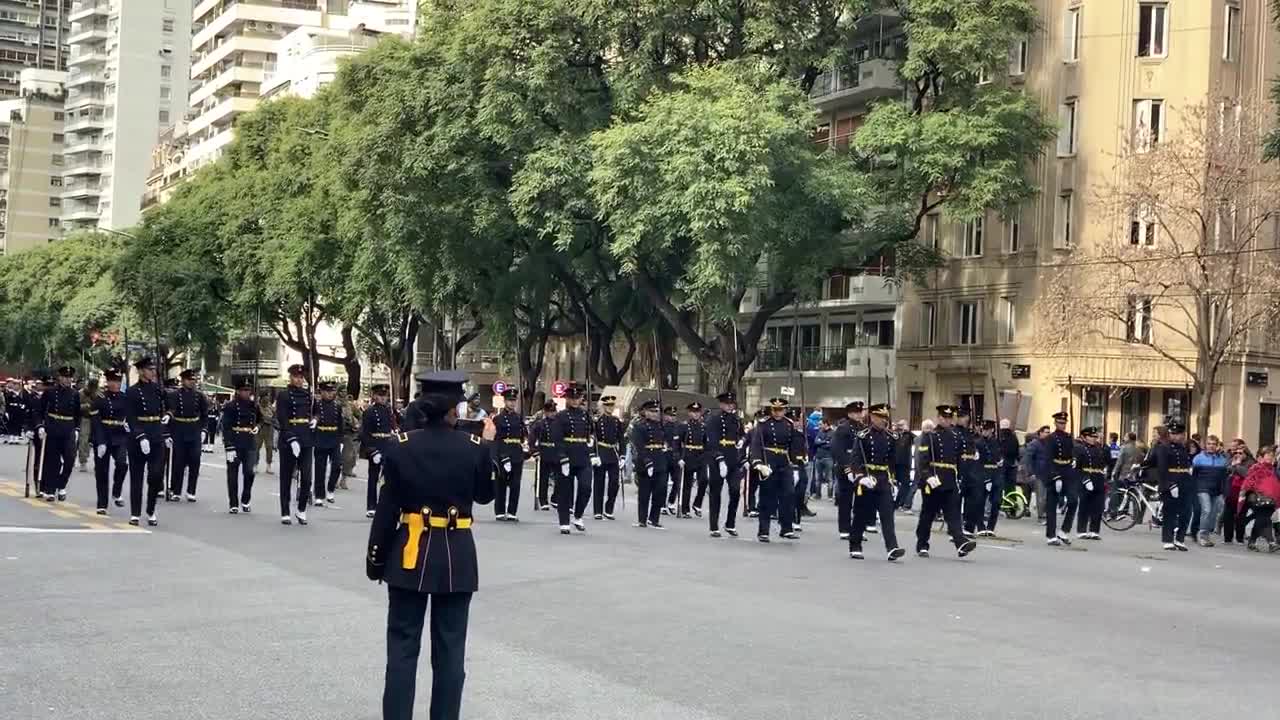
xmin=0 ymin=0 xmax=72 ymax=99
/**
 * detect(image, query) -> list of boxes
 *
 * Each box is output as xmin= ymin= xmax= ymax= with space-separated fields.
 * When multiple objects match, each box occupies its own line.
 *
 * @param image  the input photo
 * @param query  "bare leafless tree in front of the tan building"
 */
xmin=1034 ymin=100 xmax=1280 ymax=433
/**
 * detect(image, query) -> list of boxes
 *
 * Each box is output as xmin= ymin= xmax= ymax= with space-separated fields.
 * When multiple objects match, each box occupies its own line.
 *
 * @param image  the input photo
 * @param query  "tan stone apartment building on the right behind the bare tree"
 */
xmin=896 ymin=0 xmax=1280 ymax=447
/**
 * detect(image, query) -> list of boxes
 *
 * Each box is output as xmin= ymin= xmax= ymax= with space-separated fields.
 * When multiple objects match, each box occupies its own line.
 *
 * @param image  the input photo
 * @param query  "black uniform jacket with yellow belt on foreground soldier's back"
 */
xmin=366 ymin=424 xmax=494 ymax=593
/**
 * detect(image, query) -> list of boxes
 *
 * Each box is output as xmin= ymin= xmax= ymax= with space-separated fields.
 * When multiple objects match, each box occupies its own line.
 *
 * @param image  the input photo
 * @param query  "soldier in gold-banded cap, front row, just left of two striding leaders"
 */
xmin=750 ymin=397 xmax=804 ymax=542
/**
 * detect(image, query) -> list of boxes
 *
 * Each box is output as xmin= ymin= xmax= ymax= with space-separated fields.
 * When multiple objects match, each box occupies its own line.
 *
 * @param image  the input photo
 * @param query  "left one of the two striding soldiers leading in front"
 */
xmin=849 ymin=402 xmax=906 ymax=562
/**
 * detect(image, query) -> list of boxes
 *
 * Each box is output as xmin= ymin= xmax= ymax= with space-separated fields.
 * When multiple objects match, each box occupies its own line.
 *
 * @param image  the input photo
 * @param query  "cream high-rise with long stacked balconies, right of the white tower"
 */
xmin=184 ymin=0 xmax=416 ymax=167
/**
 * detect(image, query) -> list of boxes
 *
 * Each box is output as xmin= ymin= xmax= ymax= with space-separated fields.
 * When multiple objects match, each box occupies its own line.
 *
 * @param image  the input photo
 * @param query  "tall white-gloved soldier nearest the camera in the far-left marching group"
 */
xmin=124 ymin=356 xmax=168 ymax=528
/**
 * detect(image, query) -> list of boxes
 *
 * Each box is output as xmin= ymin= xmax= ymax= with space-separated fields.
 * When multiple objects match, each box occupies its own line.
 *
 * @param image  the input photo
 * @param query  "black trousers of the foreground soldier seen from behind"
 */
xmin=383 ymin=587 xmax=471 ymax=720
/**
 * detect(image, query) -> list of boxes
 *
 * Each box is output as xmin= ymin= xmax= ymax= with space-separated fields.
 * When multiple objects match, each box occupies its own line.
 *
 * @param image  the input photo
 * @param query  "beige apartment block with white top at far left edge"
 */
xmin=0 ymin=68 xmax=67 ymax=255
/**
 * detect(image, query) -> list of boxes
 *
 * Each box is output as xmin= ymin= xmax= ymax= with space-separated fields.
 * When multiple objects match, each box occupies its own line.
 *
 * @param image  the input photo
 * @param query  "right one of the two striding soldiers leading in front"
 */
xmin=915 ymin=405 xmax=978 ymax=557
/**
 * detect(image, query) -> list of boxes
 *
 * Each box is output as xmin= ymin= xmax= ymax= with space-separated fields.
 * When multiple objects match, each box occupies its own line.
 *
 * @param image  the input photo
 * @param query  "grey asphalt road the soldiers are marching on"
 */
xmin=0 ymin=446 xmax=1280 ymax=720
